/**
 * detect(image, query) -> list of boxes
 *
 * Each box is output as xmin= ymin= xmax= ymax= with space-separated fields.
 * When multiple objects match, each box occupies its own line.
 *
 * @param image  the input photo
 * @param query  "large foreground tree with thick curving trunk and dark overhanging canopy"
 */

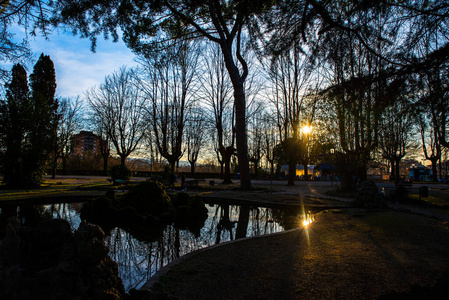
xmin=55 ymin=0 xmax=274 ymax=188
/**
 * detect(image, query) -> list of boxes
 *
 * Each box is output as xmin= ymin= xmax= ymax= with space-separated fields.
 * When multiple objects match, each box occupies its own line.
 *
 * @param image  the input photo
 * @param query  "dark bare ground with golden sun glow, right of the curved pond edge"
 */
xmin=144 ymin=210 xmax=449 ymax=299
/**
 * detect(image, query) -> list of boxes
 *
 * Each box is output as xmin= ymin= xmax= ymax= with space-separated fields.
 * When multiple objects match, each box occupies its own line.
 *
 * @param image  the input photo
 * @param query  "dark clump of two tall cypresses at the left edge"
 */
xmin=1 ymin=54 xmax=60 ymax=187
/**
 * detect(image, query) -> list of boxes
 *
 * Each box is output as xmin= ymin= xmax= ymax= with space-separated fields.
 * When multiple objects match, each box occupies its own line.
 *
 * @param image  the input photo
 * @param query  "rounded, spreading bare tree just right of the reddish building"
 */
xmin=86 ymin=67 xmax=148 ymax=167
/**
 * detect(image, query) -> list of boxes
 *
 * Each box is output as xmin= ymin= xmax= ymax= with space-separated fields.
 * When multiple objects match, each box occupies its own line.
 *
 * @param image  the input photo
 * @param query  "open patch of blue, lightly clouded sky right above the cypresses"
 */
xmin=17 ymin=26 xmax=137 ymax=98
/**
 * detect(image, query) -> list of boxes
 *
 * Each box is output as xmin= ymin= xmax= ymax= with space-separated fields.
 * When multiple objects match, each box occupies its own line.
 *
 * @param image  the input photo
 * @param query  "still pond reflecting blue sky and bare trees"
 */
xmin=0 ymin=203 xmax=310 ymax=291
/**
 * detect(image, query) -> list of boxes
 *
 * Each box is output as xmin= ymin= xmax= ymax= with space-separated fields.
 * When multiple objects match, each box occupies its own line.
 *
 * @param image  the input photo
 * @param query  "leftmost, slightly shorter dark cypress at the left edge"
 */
xmin=0 ymin=64 xmax=30 ymax=187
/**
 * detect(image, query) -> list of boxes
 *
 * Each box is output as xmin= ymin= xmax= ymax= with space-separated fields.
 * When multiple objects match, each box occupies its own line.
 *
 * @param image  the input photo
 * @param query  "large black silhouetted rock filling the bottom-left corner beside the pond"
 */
xmin=0 ymin=218 xmax=126 ymax=299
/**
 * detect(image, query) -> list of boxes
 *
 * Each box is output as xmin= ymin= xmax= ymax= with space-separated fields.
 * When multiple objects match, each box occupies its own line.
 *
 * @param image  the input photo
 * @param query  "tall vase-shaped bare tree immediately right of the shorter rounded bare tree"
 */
xmin=141 ymin=41 xmax=198 ymax=171
